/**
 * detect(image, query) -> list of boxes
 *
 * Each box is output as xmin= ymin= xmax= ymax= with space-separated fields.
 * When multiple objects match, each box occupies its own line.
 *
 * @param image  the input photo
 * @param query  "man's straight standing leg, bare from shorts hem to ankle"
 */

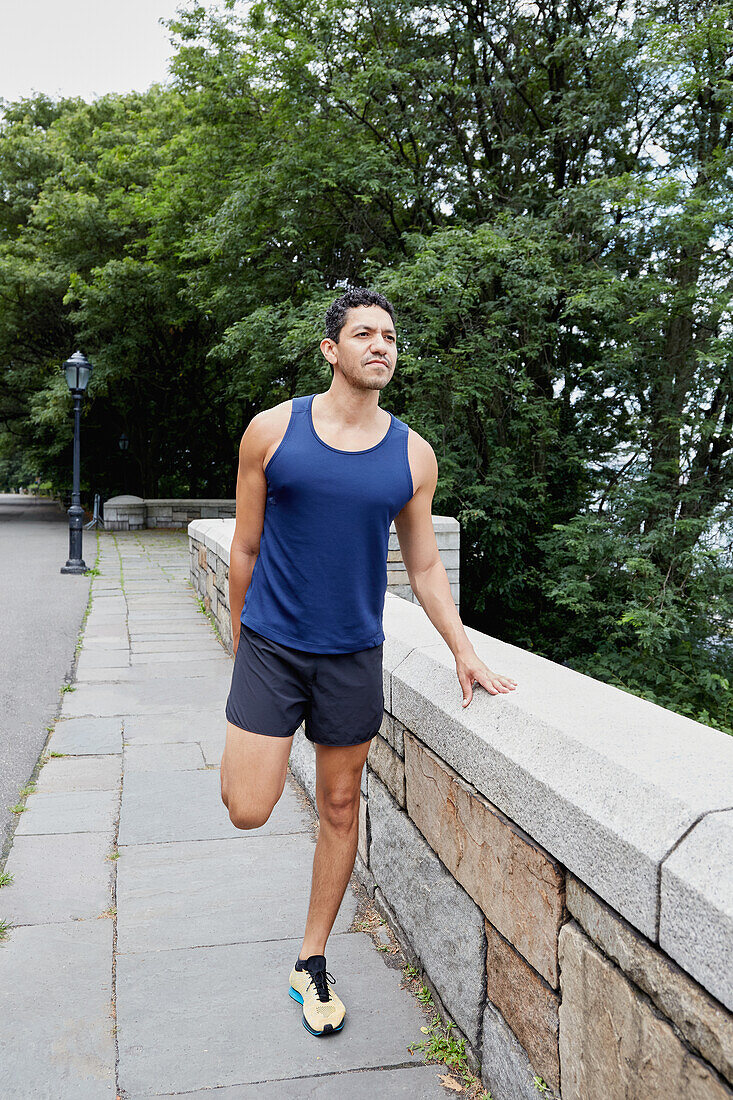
xmin=300 ymin=741 xmax=371 ymax=959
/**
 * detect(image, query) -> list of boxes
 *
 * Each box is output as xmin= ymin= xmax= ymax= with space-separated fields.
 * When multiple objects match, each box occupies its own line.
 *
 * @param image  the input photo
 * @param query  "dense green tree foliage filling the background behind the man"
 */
xmin=0 ymin=0 xmax=733 ymax=730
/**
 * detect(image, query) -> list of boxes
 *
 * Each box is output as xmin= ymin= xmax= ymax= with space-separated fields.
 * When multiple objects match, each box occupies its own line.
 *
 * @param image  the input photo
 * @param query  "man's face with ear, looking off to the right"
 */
xmin=320 ymin=306 xmax=397 ymax=389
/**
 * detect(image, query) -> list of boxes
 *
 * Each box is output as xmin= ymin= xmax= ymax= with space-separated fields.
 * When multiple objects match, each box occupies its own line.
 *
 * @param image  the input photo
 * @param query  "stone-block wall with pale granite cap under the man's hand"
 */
xmin=189 ymin=524 xmax=733 ymax=1100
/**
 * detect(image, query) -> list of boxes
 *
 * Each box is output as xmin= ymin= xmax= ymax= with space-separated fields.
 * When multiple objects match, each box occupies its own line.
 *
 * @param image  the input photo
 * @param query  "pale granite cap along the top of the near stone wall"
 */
xmin=384 ymin=593 xmax=733 ymax=1004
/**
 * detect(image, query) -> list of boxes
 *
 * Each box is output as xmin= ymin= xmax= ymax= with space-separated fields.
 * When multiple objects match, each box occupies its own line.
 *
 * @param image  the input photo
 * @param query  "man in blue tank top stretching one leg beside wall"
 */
xmin=221 ymin=288 xmax=516 ymax=1035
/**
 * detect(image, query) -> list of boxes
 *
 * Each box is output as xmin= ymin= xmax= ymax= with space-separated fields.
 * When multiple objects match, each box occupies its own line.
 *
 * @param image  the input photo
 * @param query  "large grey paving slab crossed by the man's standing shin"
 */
xmin=117 ymin=833 xmax=357 ymax=954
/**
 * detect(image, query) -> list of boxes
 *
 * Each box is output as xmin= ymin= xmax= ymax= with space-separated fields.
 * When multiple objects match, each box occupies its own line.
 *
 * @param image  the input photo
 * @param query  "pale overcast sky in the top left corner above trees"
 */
xmin=0 ymin=0 xmax=188 ymax=100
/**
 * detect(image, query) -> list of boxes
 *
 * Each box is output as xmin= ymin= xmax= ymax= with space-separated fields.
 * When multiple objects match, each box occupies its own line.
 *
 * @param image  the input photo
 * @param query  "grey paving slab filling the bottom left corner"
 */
xmin=0 ymin=919 xmax=117 ymax=1100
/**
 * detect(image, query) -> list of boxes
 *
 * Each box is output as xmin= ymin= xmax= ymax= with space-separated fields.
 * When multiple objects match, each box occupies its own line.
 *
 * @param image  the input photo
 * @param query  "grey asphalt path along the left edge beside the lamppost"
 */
xmin=0 ymin=493 xmax=97 ymax=866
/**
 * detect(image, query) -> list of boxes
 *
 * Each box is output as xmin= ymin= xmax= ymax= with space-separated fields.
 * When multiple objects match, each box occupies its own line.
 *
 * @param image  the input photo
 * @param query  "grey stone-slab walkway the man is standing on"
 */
xmin=0 ymin=531 xmax=446 ymax=1100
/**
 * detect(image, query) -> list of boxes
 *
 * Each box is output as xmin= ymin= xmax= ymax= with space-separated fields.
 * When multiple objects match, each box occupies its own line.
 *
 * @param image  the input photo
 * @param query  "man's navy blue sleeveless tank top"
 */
xmin=241 ymin=394 xmax=414 ymax=653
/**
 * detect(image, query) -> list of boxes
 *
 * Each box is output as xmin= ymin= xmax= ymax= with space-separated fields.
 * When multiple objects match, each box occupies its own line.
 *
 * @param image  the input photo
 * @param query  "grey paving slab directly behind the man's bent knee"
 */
xmin=118 ymin=768 xmax=309 ymax=847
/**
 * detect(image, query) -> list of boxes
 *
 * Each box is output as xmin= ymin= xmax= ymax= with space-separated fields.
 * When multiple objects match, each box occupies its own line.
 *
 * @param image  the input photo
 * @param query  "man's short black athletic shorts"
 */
xmin=226 ymin=623 xmax=384 ymax=746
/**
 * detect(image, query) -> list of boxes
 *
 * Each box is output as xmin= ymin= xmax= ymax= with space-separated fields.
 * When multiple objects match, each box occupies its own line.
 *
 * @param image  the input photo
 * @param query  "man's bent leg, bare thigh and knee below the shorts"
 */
xmin=220 ymin=722 xmax=294 ymax=829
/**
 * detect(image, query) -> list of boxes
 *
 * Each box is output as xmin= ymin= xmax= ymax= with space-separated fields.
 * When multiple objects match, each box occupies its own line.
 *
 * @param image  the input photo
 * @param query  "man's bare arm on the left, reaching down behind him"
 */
xmin=229 ymin=413 xmax=272 ymax=652
